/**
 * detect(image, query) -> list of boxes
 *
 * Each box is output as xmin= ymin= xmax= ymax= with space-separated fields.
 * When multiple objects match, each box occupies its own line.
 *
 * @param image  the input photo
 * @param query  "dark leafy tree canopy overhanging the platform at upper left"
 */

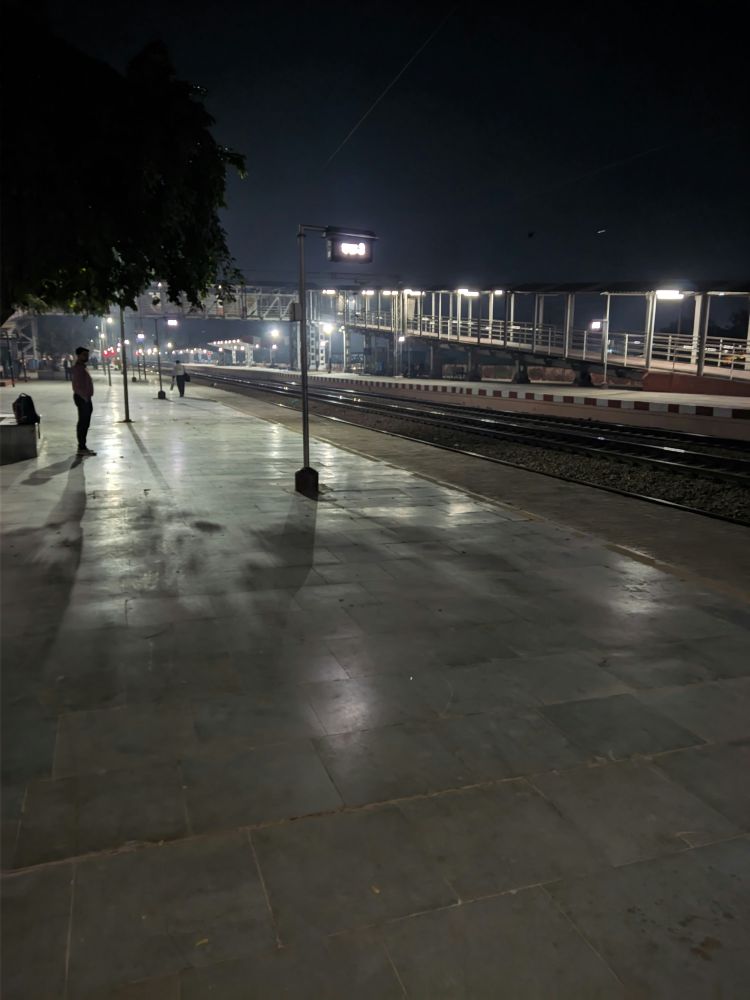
xmin=0 ymin=9 xmax=244 ymax=328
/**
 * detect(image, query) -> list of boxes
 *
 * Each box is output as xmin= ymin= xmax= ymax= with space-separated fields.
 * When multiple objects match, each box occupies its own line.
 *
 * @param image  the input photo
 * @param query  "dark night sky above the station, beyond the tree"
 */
xmin=42 ymin=0 xmax=750 ymax=288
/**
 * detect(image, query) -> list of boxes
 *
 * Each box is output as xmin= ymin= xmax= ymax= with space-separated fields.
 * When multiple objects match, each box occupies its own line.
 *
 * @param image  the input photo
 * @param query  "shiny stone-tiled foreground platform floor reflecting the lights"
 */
xmin=0 ymin=372 xmax=750 ymax=1000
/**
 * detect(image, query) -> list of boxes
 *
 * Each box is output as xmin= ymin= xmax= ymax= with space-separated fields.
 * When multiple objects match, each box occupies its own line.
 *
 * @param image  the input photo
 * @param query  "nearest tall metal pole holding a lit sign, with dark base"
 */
xmin=294 ymin=223 xmax=377 ymax=497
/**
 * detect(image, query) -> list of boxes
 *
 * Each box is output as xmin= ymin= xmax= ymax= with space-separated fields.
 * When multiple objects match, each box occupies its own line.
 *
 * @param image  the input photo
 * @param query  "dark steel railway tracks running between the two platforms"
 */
xmin=184 ymin=369 xmax=750 ymax=524
